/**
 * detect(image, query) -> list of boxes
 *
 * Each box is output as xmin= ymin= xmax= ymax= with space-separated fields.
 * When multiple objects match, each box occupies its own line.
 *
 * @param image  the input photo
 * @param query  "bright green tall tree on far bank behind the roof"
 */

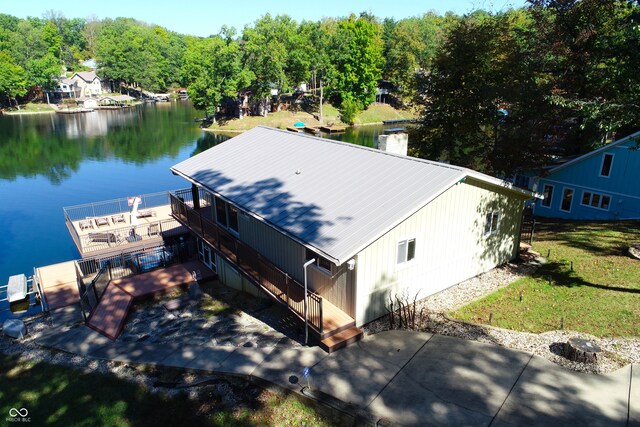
xmin=327 ymin=15 xmax=384 ymax=122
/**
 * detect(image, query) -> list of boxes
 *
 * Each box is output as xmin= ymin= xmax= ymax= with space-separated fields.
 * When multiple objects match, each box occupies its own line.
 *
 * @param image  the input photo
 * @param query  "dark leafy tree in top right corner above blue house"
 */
xmin=530 ymin=0 xmax=640 ymax=151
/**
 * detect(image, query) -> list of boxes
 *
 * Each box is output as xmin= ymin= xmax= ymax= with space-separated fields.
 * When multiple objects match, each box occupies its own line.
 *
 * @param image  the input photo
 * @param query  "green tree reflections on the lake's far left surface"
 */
xmin=0 ymin=103 xmax=200 ymax=184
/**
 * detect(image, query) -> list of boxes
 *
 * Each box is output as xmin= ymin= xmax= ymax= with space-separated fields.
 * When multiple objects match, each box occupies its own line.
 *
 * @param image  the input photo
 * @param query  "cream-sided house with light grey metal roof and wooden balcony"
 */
xmin=170 ymin=127 xmax=533 ymax=351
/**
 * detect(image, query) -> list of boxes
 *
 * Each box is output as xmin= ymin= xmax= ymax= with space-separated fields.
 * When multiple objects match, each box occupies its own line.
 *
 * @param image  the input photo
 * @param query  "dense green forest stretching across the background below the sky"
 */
xmin=0 ymin=0 xmax=640 ymax=174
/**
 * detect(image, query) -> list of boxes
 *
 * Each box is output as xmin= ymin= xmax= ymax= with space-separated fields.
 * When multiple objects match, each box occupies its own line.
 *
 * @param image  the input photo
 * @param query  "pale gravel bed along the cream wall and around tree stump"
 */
xmin=363 ymin=263 xmax=640 ymax=374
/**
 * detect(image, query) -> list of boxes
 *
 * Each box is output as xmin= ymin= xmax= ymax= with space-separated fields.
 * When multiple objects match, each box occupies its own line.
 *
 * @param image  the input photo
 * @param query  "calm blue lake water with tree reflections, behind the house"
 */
xmin=0 ymin=102 xmax=396 ymax=288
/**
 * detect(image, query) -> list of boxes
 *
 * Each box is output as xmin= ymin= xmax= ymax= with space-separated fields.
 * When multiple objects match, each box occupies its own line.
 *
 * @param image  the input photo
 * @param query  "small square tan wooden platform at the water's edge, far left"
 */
xmin=36 ymin=261 xmax=80 ymax=310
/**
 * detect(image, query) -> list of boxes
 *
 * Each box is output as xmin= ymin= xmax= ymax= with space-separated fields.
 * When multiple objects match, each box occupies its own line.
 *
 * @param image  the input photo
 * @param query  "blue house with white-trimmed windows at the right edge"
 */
xmin=532 ymin=132 xmax=640 ymax=220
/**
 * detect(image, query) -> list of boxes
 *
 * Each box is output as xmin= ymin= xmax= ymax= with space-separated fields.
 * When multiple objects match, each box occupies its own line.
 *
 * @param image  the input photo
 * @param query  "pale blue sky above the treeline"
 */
xmin=0 ymin=0 xmax=525 ymax=36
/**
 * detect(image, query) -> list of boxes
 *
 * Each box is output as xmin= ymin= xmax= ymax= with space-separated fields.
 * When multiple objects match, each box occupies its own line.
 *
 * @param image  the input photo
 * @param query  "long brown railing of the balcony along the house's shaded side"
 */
xmin=169 ymin=189 xmax=323 ymax=335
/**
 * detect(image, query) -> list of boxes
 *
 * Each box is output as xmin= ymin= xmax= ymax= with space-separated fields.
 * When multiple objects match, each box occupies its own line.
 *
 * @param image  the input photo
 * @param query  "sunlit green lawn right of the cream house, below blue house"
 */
xmin=450 ymin=221 xmax=640 ymax=337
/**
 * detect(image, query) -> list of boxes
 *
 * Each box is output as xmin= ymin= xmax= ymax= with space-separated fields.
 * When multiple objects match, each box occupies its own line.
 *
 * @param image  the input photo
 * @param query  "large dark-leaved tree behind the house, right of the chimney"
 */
xmin=415 ymin=11 xmax=555 ymax=175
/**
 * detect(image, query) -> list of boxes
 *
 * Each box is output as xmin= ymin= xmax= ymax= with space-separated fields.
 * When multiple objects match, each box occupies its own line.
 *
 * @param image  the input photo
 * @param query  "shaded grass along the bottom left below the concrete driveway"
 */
xmin=0 ymin=354 xmax=336 ymax=426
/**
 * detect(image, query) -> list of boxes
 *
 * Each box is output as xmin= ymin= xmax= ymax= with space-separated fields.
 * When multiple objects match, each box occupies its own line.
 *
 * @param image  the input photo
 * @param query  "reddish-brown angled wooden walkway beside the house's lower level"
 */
xmin=87 ymin=261 xmax=214 ymax=340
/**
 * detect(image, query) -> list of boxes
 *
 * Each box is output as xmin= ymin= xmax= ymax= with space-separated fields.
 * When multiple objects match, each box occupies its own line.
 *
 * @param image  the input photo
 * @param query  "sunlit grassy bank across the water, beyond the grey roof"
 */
xmin=209 ymin=103 xmax=415 ymax=132
